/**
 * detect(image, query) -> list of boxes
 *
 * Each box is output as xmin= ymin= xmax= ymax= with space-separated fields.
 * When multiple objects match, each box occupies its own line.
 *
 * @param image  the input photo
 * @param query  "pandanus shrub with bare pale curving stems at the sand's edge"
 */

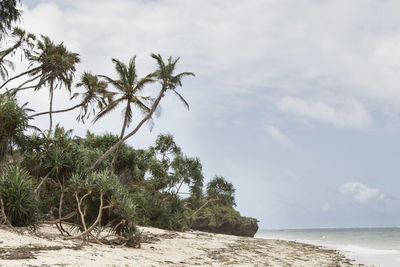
xmin=68 ymin=170 xmax=140 ymax=246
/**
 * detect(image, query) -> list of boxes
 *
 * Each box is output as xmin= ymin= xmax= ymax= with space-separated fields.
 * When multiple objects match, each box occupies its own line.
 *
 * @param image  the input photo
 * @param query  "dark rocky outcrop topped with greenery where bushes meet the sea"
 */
xmin=191 ymin=208 xmax=258 ymax=237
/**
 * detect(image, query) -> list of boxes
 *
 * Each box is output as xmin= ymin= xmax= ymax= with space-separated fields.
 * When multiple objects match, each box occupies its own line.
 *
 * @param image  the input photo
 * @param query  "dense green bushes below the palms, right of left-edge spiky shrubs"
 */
xmin=0 ymin=126 xmax=240 ymax=245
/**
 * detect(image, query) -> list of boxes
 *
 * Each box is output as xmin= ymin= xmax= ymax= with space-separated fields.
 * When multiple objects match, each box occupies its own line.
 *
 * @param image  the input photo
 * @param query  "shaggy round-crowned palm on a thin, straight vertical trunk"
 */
xmin=29 ymin=35 xmax=80 ymax=132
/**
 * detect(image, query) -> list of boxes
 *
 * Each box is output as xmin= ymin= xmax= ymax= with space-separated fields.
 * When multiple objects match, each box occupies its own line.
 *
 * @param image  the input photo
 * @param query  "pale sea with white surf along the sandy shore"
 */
xmin=255 ymin=227 xmax=400 ymax=267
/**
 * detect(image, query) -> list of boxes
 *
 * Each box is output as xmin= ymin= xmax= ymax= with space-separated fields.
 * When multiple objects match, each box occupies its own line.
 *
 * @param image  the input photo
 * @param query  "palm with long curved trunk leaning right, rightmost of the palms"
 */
xmin=91 ymin=54 xmax=195 ymax=170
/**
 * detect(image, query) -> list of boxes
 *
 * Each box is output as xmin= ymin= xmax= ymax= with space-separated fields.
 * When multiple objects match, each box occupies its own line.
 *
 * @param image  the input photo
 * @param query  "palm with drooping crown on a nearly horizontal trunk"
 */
xmin=30 ymin=72 xmax=113 ymax=122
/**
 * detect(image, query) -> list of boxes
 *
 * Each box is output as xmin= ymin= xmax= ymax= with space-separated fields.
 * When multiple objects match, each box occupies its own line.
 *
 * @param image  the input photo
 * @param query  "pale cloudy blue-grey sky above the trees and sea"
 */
xmin=7 ymin=0 xmax=400 ymax=229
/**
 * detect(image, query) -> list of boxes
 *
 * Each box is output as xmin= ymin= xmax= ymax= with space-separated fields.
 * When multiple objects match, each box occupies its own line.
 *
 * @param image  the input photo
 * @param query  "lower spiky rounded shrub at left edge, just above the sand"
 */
xmin=0 ymin=165 xmax=38 ymax=226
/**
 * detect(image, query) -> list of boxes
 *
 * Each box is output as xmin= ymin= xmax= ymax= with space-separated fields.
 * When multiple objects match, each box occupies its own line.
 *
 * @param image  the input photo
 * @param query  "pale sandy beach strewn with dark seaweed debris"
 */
xmin=0 ymin=226 xmax=372 ymax=266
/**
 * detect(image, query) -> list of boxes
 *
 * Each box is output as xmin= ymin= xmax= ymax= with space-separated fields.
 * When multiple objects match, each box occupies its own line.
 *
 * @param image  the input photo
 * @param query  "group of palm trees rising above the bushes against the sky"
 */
xmin=0 ymin=28 xmax=194 ymax=170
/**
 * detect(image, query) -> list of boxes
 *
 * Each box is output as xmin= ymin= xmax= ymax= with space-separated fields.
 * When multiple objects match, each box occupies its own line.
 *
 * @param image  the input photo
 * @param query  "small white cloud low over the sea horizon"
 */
xmin=339 ymin=182 xmax=386 ymax=204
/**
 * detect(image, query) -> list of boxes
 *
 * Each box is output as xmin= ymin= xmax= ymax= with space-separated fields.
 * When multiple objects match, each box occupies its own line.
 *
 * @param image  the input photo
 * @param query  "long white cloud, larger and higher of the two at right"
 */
xmin=277 ymin=96 xmax=372 ymax=128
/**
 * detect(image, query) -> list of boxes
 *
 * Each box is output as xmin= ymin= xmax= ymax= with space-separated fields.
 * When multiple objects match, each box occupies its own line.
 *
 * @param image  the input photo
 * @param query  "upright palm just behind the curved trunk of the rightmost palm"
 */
xmin=94 ymin=56 xmax=156 ymax=166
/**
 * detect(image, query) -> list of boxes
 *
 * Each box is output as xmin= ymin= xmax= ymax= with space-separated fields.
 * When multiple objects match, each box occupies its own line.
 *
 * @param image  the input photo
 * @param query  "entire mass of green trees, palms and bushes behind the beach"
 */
xmin=0 ymin=4 xmax=245 ymax=246
